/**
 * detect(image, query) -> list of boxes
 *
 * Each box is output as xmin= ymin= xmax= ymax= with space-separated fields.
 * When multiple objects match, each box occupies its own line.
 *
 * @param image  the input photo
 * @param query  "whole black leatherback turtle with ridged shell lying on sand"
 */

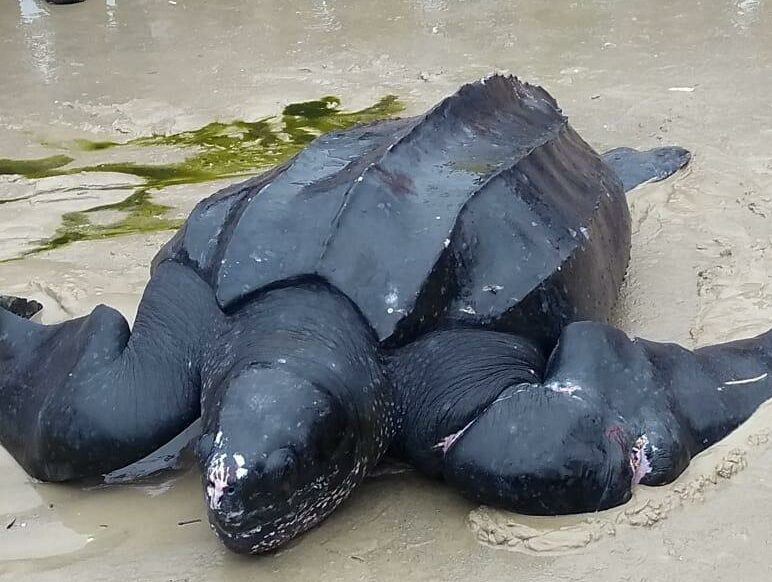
xmin=0 ymin=75 xmax=772 ymax=553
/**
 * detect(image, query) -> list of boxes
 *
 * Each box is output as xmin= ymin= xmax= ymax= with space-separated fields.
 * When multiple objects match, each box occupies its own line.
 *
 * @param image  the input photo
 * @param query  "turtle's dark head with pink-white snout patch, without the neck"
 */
xmin=198 ymin=366 xmax=364 ymax=553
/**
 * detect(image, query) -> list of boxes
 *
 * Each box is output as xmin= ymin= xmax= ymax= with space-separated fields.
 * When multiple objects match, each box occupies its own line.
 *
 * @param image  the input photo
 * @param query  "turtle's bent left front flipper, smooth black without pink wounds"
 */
xmin=0 ymin=263 xmax=220 ymax=481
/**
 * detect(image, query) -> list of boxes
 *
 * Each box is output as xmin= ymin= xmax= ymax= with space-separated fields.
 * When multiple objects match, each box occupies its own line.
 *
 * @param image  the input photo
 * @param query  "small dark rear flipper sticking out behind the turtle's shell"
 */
xmin=601 ymin=146 xmax=691 ymax=192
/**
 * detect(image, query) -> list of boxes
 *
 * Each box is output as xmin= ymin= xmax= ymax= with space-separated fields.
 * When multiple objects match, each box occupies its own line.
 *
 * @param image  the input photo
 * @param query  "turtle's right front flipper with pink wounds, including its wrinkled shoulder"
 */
xmin=392 ymin=322 xmax=772 ymax=515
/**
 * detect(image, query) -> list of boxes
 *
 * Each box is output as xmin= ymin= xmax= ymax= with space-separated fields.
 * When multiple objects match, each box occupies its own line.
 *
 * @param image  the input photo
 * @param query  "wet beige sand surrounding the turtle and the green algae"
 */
xmin=0 ymin=0 xmax=772 ymax=582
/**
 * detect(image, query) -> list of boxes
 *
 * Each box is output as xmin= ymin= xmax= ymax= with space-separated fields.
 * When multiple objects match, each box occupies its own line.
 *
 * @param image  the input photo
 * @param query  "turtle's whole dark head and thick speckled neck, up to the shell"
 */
xmin=193 ymin=282 xmax=397 ymax=552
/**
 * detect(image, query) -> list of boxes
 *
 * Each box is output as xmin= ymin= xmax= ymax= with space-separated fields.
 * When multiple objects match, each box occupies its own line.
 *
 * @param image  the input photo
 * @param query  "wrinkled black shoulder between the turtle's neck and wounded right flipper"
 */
xmin=387 ymin=329 xmax=545 ymax=477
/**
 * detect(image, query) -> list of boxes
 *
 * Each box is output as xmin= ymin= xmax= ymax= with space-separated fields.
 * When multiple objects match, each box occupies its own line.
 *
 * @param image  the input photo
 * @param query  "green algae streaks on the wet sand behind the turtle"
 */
xmin=0 ymin=95 xmax=404 ymax=255
